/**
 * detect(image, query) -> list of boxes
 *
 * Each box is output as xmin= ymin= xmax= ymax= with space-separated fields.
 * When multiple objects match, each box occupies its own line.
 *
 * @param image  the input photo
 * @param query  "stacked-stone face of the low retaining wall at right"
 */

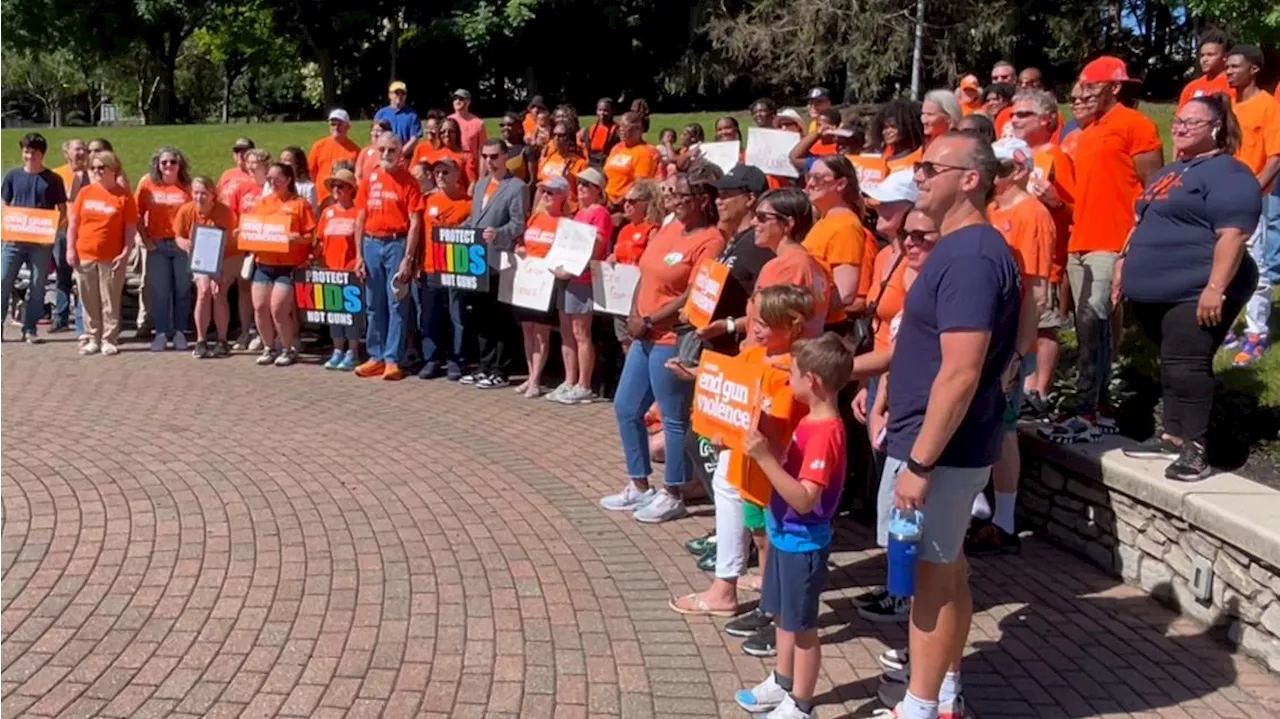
xmin=1018 ymin=435 xmax=1280 ymax=672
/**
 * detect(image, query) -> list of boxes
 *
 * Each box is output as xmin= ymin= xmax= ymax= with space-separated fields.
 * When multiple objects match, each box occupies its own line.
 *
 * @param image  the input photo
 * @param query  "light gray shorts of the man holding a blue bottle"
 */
xmin=876 ymin=457 xmax=991 ymax=564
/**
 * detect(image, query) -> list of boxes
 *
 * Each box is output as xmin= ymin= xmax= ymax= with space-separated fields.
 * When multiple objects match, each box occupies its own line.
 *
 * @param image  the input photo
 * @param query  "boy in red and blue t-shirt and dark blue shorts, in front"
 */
xmin=735 ymin=333 xmax=854 ymax=719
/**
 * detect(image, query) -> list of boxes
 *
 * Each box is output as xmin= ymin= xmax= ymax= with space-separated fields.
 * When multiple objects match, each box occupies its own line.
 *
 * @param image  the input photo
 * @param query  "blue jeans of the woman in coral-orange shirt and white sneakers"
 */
xmin=613 ymin=340 xmax=694 ymax=486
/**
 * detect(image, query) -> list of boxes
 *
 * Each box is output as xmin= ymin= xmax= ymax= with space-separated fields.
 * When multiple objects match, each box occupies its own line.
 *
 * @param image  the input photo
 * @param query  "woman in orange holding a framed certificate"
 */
xmin=173 ymin=177 xmax=236 ymax=360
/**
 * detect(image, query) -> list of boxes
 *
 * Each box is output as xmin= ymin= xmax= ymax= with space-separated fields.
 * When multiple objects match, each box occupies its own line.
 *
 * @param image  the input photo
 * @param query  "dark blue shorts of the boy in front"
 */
xmin=760 ymin=545 xmax=831 ymax=632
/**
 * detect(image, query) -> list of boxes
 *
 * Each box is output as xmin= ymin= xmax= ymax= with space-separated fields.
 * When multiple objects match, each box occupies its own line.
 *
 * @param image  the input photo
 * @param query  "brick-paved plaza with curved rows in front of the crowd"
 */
xmin=0 ymin=333 xmax=1280 ymax=719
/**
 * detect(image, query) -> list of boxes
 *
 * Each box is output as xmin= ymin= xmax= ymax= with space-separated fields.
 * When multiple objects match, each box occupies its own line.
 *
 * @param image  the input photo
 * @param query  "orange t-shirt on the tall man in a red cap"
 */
xmin=1068 ymin=105 xmax=1161 ymax=252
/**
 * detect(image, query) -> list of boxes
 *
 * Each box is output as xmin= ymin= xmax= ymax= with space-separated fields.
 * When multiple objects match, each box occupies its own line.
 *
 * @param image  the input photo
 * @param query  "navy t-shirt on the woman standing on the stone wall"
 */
xmin=1121 ymin=155 xmax=1262 ymax=302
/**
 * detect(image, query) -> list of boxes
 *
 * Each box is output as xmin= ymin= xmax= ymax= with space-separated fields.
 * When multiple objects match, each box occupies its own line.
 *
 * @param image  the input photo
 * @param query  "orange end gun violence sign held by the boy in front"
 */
xmin=691 ymin=352 xmax=764 ymax=452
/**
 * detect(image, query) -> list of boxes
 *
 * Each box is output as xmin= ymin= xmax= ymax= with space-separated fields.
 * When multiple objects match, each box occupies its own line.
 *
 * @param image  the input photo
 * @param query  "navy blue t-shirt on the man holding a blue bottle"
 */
xmin=888 ymin=225 xmax=1023 ymax=467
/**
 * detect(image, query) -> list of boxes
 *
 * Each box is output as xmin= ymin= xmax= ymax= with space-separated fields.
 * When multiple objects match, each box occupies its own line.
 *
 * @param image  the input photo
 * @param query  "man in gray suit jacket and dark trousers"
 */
xmin=449 ymin=138 xmax=525 ymax=389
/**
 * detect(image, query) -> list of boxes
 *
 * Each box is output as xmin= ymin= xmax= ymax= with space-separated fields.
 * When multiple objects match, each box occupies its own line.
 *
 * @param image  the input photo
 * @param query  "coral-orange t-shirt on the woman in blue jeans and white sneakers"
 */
xmin=632 ymin=221 xmax=724 ymax=344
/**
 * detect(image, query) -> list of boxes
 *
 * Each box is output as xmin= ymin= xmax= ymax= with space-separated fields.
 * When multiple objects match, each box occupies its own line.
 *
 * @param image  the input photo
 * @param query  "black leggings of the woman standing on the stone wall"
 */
xmin=1133 ymin=298 xmax=1244 ymax=443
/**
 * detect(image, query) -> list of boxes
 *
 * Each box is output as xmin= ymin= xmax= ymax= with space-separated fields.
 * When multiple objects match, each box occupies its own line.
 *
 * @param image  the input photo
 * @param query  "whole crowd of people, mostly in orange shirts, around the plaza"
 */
xmin=0 ymin=35 xmax=1280 ymax=719
